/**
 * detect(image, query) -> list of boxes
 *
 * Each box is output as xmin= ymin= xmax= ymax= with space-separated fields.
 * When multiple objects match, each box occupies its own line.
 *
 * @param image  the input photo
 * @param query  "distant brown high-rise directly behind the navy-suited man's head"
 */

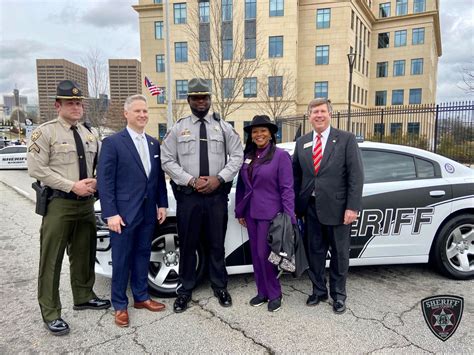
xmin=107 ymin=59 xmax=142 ymax=130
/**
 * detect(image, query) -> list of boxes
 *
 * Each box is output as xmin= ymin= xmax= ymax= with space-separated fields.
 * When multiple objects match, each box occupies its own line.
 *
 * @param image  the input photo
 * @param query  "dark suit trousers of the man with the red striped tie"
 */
xmin=305 ymin=199 xmax=351 ymax=301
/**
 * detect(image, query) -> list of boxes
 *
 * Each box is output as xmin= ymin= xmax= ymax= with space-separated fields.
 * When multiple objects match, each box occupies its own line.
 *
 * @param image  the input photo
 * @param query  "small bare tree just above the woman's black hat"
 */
xmin=257 ymin=60 xmax=296 ymax=120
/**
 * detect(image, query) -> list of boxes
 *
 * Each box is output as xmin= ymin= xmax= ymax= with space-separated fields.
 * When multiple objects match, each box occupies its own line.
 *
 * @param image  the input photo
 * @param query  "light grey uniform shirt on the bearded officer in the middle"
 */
xmin=161 ymin=113 xmax=244 ymax=186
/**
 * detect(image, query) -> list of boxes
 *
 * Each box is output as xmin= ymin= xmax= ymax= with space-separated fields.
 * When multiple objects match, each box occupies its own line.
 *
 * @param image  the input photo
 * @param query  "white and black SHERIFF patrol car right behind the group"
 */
xmin=96 ymin=142 xmax=474 ymax=295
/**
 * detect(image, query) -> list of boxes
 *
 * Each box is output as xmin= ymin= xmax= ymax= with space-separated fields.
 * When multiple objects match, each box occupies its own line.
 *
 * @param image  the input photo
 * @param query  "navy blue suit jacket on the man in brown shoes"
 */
xmin=97 ymin=129 xmax=168 ymax=224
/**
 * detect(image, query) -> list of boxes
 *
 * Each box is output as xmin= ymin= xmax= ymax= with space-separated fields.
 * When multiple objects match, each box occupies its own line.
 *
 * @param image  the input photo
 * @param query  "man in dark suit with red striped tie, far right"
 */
xmin=293 ymin=99 xmax=364 ymax=314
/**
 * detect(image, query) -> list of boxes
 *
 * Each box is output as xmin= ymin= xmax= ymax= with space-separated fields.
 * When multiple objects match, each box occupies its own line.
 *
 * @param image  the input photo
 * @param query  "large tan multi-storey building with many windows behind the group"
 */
xmin=133 ymin=0 xmax=442 ymax=140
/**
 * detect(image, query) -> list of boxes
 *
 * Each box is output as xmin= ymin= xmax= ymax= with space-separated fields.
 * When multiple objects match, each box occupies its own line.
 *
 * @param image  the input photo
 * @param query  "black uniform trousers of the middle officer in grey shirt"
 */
xmin=176 ymin=190 xmax=228 ymax=296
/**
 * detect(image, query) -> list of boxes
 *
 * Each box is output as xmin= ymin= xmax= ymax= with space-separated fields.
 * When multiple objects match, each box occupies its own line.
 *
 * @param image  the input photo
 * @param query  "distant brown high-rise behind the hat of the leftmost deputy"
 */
xmin=36 ymin=59 xmax=89 ymax=122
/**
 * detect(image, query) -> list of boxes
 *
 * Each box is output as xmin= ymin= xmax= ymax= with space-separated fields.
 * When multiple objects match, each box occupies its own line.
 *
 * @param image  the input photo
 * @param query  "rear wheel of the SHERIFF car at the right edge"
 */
xmin=433 ymin=214 xmax=474 ymax=280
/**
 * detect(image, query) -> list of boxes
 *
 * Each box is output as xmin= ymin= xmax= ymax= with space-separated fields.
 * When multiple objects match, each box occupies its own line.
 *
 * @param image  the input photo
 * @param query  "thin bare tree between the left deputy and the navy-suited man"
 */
xmin=82 ymin=48 xmax=109 ymax=136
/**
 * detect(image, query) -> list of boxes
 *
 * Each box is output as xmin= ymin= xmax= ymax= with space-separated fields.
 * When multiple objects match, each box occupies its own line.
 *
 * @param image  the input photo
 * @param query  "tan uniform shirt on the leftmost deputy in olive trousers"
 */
xmin=27 ymin=117 xmax=98 ymax=192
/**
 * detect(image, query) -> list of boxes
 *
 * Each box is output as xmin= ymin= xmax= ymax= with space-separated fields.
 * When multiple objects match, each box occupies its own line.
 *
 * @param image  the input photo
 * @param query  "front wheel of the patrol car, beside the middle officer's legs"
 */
xmin=148 ymin=224 xmax=204 ymax=297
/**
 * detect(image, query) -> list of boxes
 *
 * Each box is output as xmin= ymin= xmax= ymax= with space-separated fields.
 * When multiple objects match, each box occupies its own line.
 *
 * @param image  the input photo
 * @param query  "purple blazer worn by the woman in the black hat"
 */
xmin=235 ymin=148 xmax=296 ymax=223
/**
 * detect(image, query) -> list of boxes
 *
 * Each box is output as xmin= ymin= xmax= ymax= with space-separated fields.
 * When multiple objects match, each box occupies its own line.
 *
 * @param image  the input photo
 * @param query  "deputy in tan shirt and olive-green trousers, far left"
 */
xmin=27 ymin=80 xmax=110 ymax=335
